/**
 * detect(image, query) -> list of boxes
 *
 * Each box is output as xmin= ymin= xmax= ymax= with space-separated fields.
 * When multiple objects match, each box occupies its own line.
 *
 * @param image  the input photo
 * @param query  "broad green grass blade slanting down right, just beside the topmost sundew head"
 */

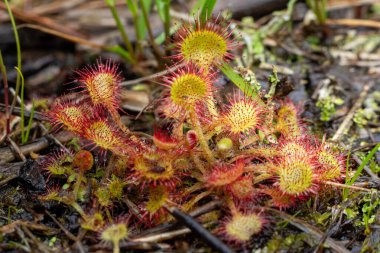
xmin=219 ymin=63 xmax=264 ymax=105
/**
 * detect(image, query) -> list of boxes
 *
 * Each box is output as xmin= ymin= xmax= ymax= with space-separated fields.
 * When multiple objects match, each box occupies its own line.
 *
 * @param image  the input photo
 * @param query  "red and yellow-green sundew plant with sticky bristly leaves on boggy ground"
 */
xmin=40 ymin=15 xmax=345 ymax=247
